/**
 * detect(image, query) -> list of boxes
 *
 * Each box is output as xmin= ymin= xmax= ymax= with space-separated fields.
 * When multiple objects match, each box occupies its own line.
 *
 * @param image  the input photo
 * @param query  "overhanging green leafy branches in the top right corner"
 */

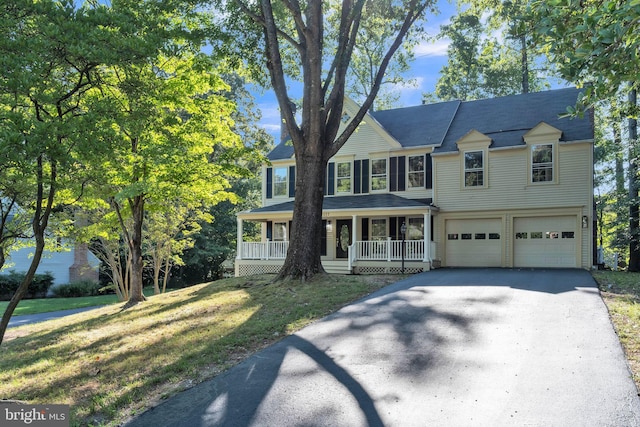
xmin=531 ymin=0 xmax=640 ymax=106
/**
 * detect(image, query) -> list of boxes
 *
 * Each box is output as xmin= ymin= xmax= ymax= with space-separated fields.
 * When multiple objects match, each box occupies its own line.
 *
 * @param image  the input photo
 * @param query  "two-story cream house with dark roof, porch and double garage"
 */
xmin=235 ymin=88 xmax=594 ymax=275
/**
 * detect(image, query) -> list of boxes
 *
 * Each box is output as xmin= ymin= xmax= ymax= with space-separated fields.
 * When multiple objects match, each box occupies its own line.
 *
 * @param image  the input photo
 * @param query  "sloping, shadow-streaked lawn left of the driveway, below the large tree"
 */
xmin=0 ymin=275 xmax=400 ymax=426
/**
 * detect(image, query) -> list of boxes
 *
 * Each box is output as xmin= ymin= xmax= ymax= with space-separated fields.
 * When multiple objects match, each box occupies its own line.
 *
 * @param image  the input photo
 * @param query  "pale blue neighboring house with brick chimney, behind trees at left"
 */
xmin=1 ymin=244 xmax=100 ymax=285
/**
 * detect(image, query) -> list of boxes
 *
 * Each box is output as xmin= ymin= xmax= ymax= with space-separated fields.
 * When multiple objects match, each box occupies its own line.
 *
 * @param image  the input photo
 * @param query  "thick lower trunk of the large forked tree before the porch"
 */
xmin=278 ymin=150 xmax=327 ymax=280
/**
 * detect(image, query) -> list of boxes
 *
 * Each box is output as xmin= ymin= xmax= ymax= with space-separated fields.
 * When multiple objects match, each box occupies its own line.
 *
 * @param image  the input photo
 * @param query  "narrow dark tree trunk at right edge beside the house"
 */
xmin=629 ymin=89 xmax=640 ymax=271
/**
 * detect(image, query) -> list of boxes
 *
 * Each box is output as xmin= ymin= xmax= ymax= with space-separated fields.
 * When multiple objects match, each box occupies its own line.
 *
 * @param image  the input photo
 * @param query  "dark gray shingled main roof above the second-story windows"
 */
xmin=268 ymin=88 xmax=593 ymax=160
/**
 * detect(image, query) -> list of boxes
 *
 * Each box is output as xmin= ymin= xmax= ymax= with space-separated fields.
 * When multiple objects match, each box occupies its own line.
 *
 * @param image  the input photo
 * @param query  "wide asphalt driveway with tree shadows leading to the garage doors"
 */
xmin=127 ymin=269 xmax=640 ymax=427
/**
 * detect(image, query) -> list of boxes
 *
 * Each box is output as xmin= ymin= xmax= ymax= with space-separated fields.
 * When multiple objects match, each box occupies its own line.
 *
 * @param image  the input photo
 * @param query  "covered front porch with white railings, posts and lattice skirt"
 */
xmin=235 ymin=194 xmax=437 ymax=276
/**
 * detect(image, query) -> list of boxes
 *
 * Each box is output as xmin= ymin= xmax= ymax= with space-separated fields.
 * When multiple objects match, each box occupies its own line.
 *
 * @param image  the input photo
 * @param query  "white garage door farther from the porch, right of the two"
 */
xmin=513 ymin=216 xmax=579 ymax=267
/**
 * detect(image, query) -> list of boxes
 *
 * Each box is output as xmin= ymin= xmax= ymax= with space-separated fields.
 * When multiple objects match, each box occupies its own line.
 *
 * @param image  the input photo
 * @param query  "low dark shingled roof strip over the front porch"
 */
xmin=239 ymin=193 xmax=432 ymax=218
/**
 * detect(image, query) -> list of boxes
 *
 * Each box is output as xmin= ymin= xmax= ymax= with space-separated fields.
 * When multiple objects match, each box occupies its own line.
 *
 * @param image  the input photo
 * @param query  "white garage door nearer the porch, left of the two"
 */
xmin=445 ymin=219 xmax=502 ymax=267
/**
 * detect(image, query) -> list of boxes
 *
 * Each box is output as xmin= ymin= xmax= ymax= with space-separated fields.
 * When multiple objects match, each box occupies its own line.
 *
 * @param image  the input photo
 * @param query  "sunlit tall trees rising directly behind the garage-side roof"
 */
xmin=432 ymin=0 xmax=548 ymax=101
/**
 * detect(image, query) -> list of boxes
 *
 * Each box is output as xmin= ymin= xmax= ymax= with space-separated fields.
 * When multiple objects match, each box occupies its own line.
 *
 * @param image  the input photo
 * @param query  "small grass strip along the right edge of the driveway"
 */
xmin=593 ymin=271 xmax=640 ymax=389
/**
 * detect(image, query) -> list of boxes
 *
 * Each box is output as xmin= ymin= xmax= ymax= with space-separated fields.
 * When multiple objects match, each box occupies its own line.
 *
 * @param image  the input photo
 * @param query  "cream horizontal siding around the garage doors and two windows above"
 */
xmin=433 ymin=143 xmax=593 ymax=268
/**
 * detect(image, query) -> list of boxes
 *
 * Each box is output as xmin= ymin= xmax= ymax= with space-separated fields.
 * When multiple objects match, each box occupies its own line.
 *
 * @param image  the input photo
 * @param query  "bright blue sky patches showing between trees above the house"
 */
xmin=256 ymin=0 xmax=456 ymax=142
